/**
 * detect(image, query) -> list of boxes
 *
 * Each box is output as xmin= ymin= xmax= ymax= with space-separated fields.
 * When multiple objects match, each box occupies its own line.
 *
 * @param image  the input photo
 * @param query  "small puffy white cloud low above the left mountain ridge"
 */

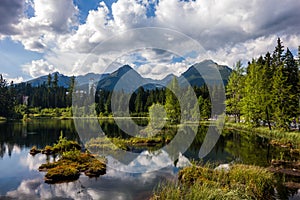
xmin=23 ymin=59 xmax=57 ymax=78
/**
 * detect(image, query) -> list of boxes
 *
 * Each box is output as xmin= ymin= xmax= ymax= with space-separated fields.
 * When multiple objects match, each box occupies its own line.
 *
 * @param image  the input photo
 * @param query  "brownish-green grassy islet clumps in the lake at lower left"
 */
xmin=30 ymin=135 xmax=106 ymax=184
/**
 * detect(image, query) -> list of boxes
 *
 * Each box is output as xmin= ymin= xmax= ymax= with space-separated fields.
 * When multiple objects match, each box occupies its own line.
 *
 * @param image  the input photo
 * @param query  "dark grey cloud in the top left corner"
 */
xmin=0 ymin=0 xmax=24 ymax=34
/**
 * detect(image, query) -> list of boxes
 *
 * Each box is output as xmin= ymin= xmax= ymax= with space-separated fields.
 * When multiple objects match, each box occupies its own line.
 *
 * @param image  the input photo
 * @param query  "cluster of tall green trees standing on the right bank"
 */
xmin=226 ymin=38 xmax=300 ymax=130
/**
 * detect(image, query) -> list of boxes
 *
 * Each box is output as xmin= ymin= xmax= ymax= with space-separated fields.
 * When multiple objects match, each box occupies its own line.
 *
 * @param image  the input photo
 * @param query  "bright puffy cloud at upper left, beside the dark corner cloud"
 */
xmin=12 ymin=0 xmax=78 ymax=52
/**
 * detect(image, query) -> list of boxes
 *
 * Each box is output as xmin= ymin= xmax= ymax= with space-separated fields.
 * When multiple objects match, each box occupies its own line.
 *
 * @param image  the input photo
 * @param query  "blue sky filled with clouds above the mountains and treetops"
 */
xmin=0 ymin=0 xmax=300 ymax=82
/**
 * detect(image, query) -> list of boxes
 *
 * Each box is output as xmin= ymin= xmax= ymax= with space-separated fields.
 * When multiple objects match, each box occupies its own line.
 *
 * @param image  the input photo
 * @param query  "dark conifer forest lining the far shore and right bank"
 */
xmin=0 ymin=38 xmax=300 ymax=130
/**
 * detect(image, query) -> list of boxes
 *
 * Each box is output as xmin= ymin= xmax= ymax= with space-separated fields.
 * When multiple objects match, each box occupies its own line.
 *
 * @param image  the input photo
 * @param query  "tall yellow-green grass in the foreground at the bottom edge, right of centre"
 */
xmin=151 ymin=164 xmax=275 ymax=200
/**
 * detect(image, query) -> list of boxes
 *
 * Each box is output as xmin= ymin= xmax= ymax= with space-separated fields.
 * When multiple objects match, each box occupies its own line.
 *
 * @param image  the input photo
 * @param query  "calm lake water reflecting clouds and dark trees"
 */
xmin=0 ymin=119 xmax=299 ymax=200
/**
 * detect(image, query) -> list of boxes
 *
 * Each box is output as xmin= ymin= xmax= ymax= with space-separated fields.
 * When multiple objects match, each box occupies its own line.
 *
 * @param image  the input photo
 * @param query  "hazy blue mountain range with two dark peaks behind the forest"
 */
xmin=27 ymin=60 xmax=232 ymax=91
